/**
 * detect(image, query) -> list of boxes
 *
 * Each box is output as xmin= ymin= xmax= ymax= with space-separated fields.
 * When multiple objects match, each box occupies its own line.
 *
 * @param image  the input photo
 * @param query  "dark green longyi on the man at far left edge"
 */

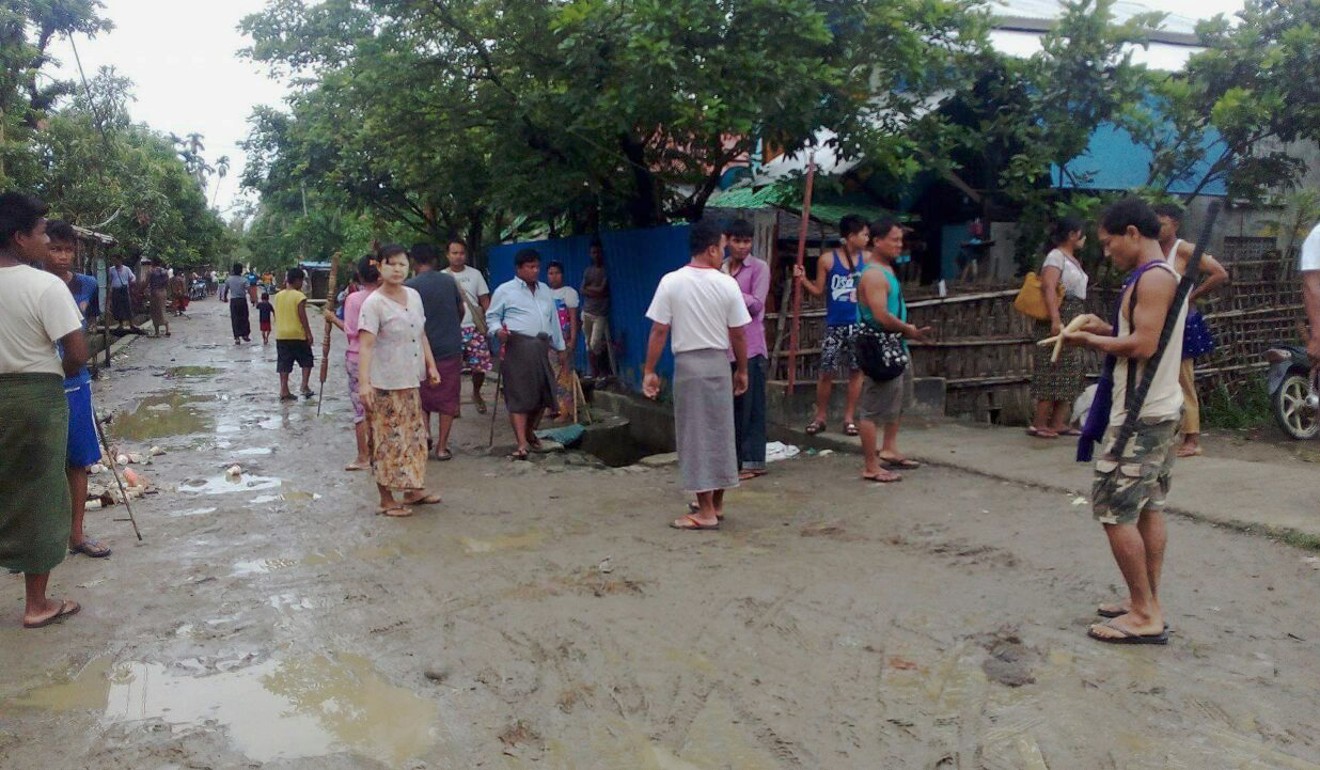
xmin=0 ymin=374 xmax=73 ymax=575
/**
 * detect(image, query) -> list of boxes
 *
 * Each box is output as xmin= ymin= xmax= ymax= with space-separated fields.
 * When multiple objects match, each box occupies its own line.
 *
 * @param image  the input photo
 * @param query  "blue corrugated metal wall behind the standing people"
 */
xmin=487 ymin=225 xmax=688 ymax=388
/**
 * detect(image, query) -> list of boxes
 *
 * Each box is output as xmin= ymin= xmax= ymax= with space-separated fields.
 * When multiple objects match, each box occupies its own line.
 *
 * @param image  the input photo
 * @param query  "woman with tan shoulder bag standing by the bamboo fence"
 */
xmin=1027 ymin=217 xmax=1090 ymax=438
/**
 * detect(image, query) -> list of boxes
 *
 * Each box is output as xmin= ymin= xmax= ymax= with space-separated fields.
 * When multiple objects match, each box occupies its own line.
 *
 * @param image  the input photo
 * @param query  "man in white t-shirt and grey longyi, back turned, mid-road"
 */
xmin=642 ymin=219 xmax=751 ymax=530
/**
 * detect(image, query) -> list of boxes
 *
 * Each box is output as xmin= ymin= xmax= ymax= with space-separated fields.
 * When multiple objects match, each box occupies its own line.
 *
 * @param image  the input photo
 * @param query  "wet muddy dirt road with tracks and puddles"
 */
xmin=0 ymin=301 xmax=1320 ymax=770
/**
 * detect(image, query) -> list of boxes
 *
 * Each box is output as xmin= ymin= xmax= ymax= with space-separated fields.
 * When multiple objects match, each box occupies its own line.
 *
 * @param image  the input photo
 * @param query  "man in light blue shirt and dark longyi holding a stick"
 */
xmin=486 ymin=248 xmax=569 ymax=460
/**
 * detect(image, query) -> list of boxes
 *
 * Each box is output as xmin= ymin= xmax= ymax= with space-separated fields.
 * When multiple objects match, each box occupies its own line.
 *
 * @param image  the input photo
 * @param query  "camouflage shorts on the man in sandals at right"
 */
xmin=1090 ymin=420 xmax=1179 ymax=524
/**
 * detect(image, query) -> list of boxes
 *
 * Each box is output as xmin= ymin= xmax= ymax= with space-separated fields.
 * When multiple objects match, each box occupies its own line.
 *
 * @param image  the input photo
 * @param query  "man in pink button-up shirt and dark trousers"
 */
xmin=723 ymin=219 xmax=770 ymax=481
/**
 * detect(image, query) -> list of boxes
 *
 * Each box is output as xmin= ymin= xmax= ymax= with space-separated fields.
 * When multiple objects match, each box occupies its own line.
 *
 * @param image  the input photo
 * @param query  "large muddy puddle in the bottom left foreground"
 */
xmin=13 ymin=654 xmax=440 ymax=767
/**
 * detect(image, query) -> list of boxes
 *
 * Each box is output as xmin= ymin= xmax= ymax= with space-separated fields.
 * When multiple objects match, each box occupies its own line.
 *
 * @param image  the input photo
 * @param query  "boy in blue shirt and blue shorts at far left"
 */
xmin=46 ymin=219 xmax=110 ymax=559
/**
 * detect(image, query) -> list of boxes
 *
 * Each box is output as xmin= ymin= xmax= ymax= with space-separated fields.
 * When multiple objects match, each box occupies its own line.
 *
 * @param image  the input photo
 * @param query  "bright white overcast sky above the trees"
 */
xmin=54 ymin=0 xmax=1242 ymax=216
